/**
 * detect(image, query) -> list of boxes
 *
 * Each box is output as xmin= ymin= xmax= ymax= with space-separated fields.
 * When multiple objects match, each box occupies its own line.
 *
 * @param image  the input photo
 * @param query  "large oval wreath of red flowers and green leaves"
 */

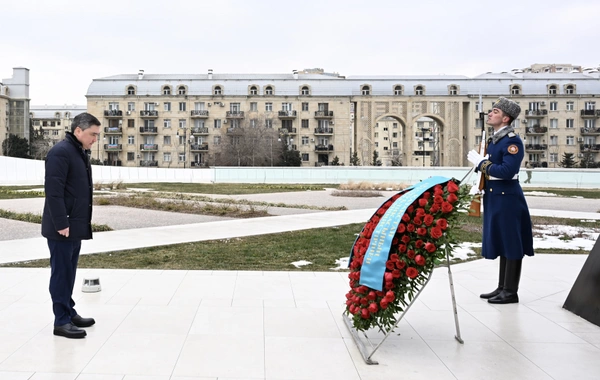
xmin=345 ymin=179 xmax=469 ymax=331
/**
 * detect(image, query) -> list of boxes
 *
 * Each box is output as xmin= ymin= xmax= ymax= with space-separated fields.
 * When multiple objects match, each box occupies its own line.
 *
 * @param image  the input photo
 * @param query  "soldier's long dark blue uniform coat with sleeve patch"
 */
xmin=478 ymin=127 xmax=533 ymax=260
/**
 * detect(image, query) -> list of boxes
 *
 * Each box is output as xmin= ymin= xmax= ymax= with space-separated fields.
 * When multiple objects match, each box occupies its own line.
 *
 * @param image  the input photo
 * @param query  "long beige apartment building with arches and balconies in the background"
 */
xmin=86 ymin=68 xmax=600 ymax=168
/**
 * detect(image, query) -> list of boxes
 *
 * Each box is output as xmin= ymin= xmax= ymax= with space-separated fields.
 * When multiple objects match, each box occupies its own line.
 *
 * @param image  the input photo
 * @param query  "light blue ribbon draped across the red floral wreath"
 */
xmin=350 ymin=176 xmax=451 ymax=290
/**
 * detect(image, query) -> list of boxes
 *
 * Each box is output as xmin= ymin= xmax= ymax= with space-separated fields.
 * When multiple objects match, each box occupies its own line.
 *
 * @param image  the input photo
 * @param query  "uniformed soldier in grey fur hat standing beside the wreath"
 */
xmin=467 ymin=98 xmax=533 ymax=304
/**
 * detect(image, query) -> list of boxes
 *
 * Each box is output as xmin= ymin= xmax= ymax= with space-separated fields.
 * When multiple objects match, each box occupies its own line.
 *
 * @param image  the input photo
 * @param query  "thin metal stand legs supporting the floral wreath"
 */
xmin=342 ymin=251 xmax=465 ymax=365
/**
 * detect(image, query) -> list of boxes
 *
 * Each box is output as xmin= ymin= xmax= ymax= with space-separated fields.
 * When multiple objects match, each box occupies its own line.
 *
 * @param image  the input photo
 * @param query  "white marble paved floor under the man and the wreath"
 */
xmin=0 ymin=255 xmax=600 ymax=380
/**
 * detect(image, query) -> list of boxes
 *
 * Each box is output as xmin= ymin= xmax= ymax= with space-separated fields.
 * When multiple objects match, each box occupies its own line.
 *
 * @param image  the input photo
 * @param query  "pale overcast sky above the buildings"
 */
xmin=0 ymin=0 xmax=600 ymax=105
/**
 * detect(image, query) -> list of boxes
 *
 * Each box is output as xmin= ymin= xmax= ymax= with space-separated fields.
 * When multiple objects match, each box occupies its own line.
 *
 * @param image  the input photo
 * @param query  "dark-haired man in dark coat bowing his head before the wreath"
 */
xmin=42 ymin=113 xmax=100 ymax=338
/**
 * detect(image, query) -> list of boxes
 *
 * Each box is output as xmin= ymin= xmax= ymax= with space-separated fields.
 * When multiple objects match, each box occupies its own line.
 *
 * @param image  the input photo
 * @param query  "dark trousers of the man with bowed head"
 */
xmin=48 ymin=239 xmax=81 ymax=326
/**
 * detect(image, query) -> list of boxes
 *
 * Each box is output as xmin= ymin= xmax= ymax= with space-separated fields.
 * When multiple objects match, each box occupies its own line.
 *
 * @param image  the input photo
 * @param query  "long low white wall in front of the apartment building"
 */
xmin=0 ymin=156 xmax=600 ymax=189
